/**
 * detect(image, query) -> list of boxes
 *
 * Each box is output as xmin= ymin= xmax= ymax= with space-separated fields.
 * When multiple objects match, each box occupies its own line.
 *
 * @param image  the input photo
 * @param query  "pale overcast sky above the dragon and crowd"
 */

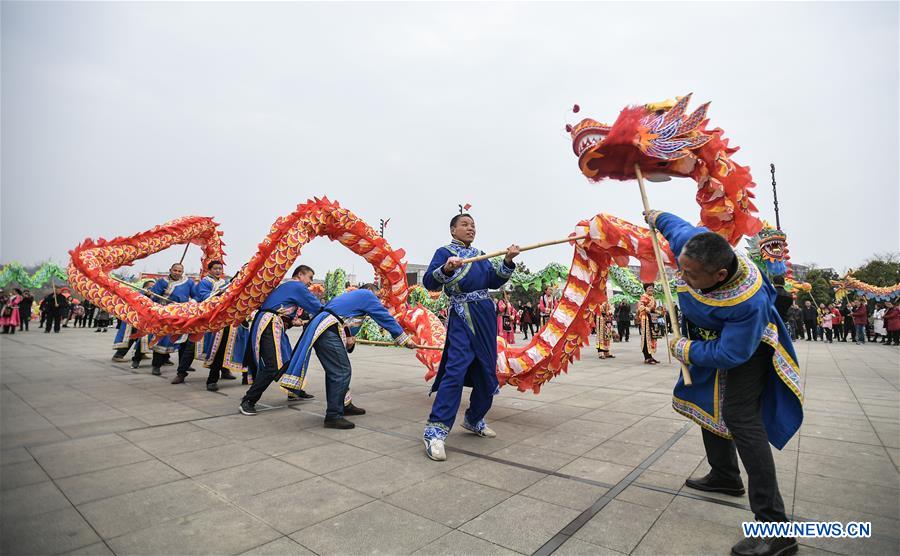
xmin=0 ymin=2 xmax=900 ymax=278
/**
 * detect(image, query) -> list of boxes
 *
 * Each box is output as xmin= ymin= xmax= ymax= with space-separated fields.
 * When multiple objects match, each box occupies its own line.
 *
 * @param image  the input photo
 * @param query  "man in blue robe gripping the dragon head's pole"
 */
xmin=647 ymin=211 xmax=803 ymax=556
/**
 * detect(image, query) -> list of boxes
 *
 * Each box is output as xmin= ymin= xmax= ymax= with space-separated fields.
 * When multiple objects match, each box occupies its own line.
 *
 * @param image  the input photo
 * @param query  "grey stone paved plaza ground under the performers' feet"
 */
xmin=0 ymin=329 xmax=900 ymax=554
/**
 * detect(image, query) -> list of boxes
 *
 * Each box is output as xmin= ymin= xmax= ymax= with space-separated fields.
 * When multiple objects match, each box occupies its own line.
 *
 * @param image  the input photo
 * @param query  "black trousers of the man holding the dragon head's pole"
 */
xmin=703 ymin=353 xmax=787 ymax=521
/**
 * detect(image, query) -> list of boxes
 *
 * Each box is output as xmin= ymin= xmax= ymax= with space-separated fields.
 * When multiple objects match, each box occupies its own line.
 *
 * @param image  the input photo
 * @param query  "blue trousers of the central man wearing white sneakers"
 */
xmin=428 ymin=343 xmax=496 ymax=430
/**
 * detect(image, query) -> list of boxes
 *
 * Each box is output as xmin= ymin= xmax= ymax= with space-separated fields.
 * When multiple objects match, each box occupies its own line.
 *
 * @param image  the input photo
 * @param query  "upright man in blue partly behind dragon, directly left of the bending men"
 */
xmin=197 ymin=261 xmax=248 ymax=392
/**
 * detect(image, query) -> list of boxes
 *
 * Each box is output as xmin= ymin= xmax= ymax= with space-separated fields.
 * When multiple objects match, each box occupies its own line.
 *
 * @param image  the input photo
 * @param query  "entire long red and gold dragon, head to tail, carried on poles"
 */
xmin=68 ymin=96 xmax=761 ymax=393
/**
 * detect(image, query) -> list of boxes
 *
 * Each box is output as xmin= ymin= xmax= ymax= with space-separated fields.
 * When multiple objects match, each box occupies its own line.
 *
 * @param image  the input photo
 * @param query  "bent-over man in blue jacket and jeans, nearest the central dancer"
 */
xmin=280 ymin=284 xmax=415 ymax=429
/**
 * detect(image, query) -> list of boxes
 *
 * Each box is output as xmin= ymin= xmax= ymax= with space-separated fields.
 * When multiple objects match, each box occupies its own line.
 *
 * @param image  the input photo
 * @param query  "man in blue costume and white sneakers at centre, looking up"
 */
xmin=423 ymin=214 xmax=519 ymax=461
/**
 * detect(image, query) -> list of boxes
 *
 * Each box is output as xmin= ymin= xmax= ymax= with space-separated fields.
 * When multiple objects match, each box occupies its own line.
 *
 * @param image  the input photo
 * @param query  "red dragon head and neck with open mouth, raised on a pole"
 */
xmin=566 ymin=95 xmax=762 ymax=245
